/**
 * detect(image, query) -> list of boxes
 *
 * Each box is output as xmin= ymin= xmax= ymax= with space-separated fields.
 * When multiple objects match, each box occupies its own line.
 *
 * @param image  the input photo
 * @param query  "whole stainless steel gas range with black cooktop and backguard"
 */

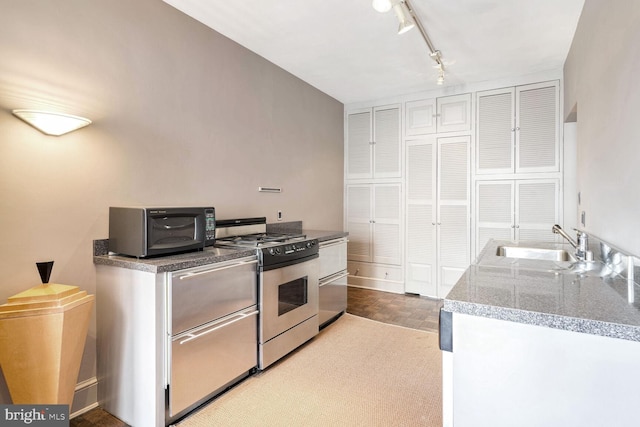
xmin=216 ymin=217 xmax=319 ymax=369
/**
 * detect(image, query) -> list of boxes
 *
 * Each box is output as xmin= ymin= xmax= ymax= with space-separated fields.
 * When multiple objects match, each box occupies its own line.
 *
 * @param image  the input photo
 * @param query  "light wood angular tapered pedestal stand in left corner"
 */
xmin=0 ymin=284 xmax=95 ymax=409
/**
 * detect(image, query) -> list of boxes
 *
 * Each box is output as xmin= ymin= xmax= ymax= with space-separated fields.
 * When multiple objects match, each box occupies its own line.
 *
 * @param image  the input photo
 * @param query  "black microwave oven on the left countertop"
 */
xmin=109 ymin=207 xmax=216 ymax=258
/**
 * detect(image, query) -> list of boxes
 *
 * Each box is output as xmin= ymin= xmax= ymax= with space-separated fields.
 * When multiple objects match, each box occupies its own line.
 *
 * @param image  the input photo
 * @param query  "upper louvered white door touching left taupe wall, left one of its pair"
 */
xmin=347 ymin=110 xmax=373 ymax=179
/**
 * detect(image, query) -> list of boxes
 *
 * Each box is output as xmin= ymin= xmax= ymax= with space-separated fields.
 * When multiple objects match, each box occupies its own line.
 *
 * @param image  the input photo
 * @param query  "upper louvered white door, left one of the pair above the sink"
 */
xmin=476 ymin=88 xmax=515 ymax=174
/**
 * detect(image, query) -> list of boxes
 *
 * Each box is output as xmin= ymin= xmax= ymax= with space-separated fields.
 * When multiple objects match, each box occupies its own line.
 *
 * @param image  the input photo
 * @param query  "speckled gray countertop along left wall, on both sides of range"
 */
xmin=93 ymin=230 xmax=348 ymax=273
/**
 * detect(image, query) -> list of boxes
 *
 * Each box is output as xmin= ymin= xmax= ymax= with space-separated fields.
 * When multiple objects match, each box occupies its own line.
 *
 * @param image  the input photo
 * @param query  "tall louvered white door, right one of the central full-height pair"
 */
xmin=437 ymin=136 xmax=471 ymax=298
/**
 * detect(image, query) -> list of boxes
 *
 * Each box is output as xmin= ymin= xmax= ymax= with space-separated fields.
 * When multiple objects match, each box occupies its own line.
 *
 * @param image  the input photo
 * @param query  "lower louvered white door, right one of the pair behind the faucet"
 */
xmin=515 ymin=179 xmax=559 ymax=242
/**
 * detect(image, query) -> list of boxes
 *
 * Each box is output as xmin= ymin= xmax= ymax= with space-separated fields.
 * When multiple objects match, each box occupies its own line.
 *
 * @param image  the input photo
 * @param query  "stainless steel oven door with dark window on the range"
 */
xmin=260 ymin=258 xmax=319 ymax=343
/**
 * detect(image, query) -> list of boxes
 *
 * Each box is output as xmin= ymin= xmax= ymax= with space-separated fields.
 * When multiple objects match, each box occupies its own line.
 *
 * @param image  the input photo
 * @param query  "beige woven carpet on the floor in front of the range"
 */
xmin=179 ymin=314 xmax=442 ymax=427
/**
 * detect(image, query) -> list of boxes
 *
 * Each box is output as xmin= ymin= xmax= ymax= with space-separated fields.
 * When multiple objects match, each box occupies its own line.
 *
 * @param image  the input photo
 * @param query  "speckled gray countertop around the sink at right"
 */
xmin=443 ymin=241 xmax=640 ymax=341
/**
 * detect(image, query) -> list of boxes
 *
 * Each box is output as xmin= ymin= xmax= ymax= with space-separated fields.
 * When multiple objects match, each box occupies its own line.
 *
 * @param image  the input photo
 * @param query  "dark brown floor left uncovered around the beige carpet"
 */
xmin=70 ymin=286 xmax=442 ymax=427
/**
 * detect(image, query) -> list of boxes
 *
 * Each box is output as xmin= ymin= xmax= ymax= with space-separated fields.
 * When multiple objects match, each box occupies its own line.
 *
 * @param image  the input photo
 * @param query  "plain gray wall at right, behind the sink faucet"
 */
xmin=564 ymin=0 xmax=640 ymax=256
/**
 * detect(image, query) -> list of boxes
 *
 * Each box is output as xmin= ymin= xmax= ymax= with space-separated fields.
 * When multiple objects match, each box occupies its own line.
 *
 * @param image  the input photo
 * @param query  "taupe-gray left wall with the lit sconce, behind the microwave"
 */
xmin=0 ymin=0 xmax=343 ymax=403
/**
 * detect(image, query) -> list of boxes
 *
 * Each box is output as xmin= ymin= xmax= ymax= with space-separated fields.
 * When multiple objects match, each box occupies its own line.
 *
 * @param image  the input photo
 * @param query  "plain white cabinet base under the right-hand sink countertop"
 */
xmin=443 ymin=313 xmax=640 ymax=427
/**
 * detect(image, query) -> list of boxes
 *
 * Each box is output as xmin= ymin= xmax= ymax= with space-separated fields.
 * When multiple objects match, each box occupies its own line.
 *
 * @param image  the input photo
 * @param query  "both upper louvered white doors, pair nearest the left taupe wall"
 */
xmin=346 ymin=105 xmax=401 ymax=179
